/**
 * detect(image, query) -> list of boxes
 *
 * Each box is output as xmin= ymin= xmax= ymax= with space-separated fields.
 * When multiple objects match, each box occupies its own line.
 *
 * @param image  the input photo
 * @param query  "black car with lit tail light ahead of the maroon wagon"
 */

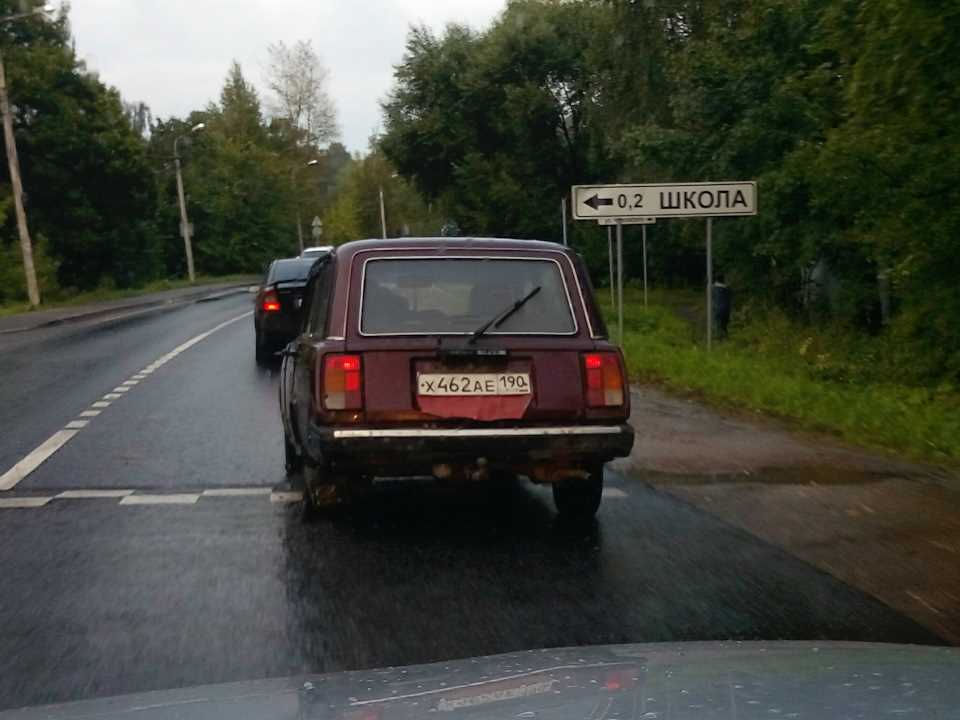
xmin=253 ymin=257 xmax=317 ymax=364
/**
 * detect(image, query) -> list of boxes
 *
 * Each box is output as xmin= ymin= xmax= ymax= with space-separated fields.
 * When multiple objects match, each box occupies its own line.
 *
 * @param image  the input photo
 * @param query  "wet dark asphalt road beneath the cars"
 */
xmin=0 ymin=295 xmax=938 ymax=709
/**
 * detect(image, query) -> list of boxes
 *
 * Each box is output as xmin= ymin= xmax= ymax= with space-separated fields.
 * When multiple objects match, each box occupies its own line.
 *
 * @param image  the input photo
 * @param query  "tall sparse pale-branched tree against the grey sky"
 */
xmin=267 ymin=40 xmax=338 ymax=147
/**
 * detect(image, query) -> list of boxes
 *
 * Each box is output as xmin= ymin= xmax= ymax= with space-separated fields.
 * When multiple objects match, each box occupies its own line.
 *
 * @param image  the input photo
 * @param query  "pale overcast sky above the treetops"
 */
xmin=70 ymin=0 xmax=505 ymax=151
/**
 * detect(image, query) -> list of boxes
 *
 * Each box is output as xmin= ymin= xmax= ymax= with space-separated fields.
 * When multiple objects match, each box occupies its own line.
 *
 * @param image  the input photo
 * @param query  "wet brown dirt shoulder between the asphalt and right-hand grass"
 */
xmin=616 ymin=388 xmax=960 ymax=643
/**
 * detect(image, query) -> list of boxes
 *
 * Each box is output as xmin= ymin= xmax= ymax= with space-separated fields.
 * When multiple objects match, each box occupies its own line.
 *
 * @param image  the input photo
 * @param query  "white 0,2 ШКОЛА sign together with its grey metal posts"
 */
xmin=571 ymin=181 xmax=757 ymax=348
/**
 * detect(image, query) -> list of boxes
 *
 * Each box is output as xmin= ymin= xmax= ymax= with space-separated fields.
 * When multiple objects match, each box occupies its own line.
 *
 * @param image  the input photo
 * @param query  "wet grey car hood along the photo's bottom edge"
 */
xmin=0 ymin=642 xmax=960 ymax=720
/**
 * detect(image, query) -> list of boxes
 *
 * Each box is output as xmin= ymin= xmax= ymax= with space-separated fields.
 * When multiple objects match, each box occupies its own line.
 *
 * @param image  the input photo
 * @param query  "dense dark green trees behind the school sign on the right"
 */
xmin=380 ymin=0 xmax=960 ymax=380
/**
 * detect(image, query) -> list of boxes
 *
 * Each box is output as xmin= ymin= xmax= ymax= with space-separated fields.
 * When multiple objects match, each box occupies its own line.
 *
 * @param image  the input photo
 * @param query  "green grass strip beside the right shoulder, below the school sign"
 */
xmin=598 ymin=288 xmax=960 ymax=465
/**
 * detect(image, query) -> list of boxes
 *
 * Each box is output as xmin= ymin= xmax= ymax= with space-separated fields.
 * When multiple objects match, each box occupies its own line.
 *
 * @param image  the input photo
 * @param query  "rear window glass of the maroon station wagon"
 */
xmin=360 ymin=257 xmax=577 ymax=335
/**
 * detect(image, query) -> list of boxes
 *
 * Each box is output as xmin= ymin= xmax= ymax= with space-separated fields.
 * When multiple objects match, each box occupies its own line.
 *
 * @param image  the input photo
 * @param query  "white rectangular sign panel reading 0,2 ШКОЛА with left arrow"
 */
xmin=573 ymin=182 xmax=757 ymax=220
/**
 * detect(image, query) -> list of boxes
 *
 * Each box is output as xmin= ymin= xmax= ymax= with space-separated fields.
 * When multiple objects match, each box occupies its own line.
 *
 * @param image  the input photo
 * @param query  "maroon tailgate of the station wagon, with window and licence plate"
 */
xmin=348 ymin=251 xmax=593 ymax=426
